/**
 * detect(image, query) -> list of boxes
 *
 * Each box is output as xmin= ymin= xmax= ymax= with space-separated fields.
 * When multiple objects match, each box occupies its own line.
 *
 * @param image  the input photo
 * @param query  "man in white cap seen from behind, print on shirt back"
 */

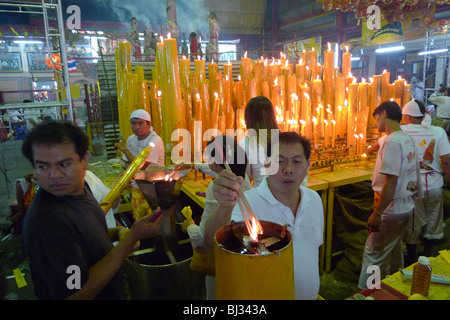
xmin=401 ymin=100 xmax=450 ymax=263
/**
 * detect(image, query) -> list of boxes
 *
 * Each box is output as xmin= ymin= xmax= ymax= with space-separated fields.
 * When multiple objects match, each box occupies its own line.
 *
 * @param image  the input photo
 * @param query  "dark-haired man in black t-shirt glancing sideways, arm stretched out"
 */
xmin=22 ymin=122 xmax=161 ymax=299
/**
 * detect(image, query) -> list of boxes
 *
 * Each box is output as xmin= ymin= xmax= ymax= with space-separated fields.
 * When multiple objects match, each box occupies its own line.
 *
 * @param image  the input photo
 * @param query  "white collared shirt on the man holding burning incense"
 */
xmin=231 ymin=177 xmax=324 ymax=300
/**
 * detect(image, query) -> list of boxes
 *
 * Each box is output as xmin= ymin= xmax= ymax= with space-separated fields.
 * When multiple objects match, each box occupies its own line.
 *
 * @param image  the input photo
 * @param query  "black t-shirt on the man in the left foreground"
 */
xmin=23 ymin=187 xmax=124 ymax=300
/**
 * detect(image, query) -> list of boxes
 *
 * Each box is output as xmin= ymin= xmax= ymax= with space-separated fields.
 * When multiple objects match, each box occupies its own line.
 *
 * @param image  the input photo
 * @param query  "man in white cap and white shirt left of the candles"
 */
xmin=116 ymin=109 xmax=164 ymax=167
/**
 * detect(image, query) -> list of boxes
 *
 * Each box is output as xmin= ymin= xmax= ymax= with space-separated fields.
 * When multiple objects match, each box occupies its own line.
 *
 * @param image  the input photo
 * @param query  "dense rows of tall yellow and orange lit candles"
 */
xmin=116 ymin=35 xmax=411 ymax=162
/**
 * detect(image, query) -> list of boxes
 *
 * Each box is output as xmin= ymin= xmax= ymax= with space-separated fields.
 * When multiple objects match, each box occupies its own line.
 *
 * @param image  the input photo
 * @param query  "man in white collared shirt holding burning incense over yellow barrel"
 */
xmin=204 ymin=132 xmax=324 ymax=300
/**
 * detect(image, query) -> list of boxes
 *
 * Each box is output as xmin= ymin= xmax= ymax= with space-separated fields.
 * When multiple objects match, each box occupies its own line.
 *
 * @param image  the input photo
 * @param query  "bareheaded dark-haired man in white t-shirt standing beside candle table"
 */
xmin=358 ymin=101 xmax=421 ymax=289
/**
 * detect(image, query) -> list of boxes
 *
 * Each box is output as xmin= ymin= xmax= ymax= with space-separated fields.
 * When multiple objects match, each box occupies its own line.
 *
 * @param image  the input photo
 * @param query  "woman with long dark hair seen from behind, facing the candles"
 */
xmin=239 ymin=96 xmax=279 ymax=187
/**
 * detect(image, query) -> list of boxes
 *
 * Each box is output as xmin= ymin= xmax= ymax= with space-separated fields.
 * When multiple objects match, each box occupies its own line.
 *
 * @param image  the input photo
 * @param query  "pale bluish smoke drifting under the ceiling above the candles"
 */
xmin=96 ymin=0 xmax=209 ymax=40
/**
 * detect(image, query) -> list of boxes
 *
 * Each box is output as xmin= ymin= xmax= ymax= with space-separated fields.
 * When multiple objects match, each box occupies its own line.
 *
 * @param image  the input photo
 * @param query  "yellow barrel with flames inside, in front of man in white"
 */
xmin=214 ymin=221 xmax=295 ymax=300
